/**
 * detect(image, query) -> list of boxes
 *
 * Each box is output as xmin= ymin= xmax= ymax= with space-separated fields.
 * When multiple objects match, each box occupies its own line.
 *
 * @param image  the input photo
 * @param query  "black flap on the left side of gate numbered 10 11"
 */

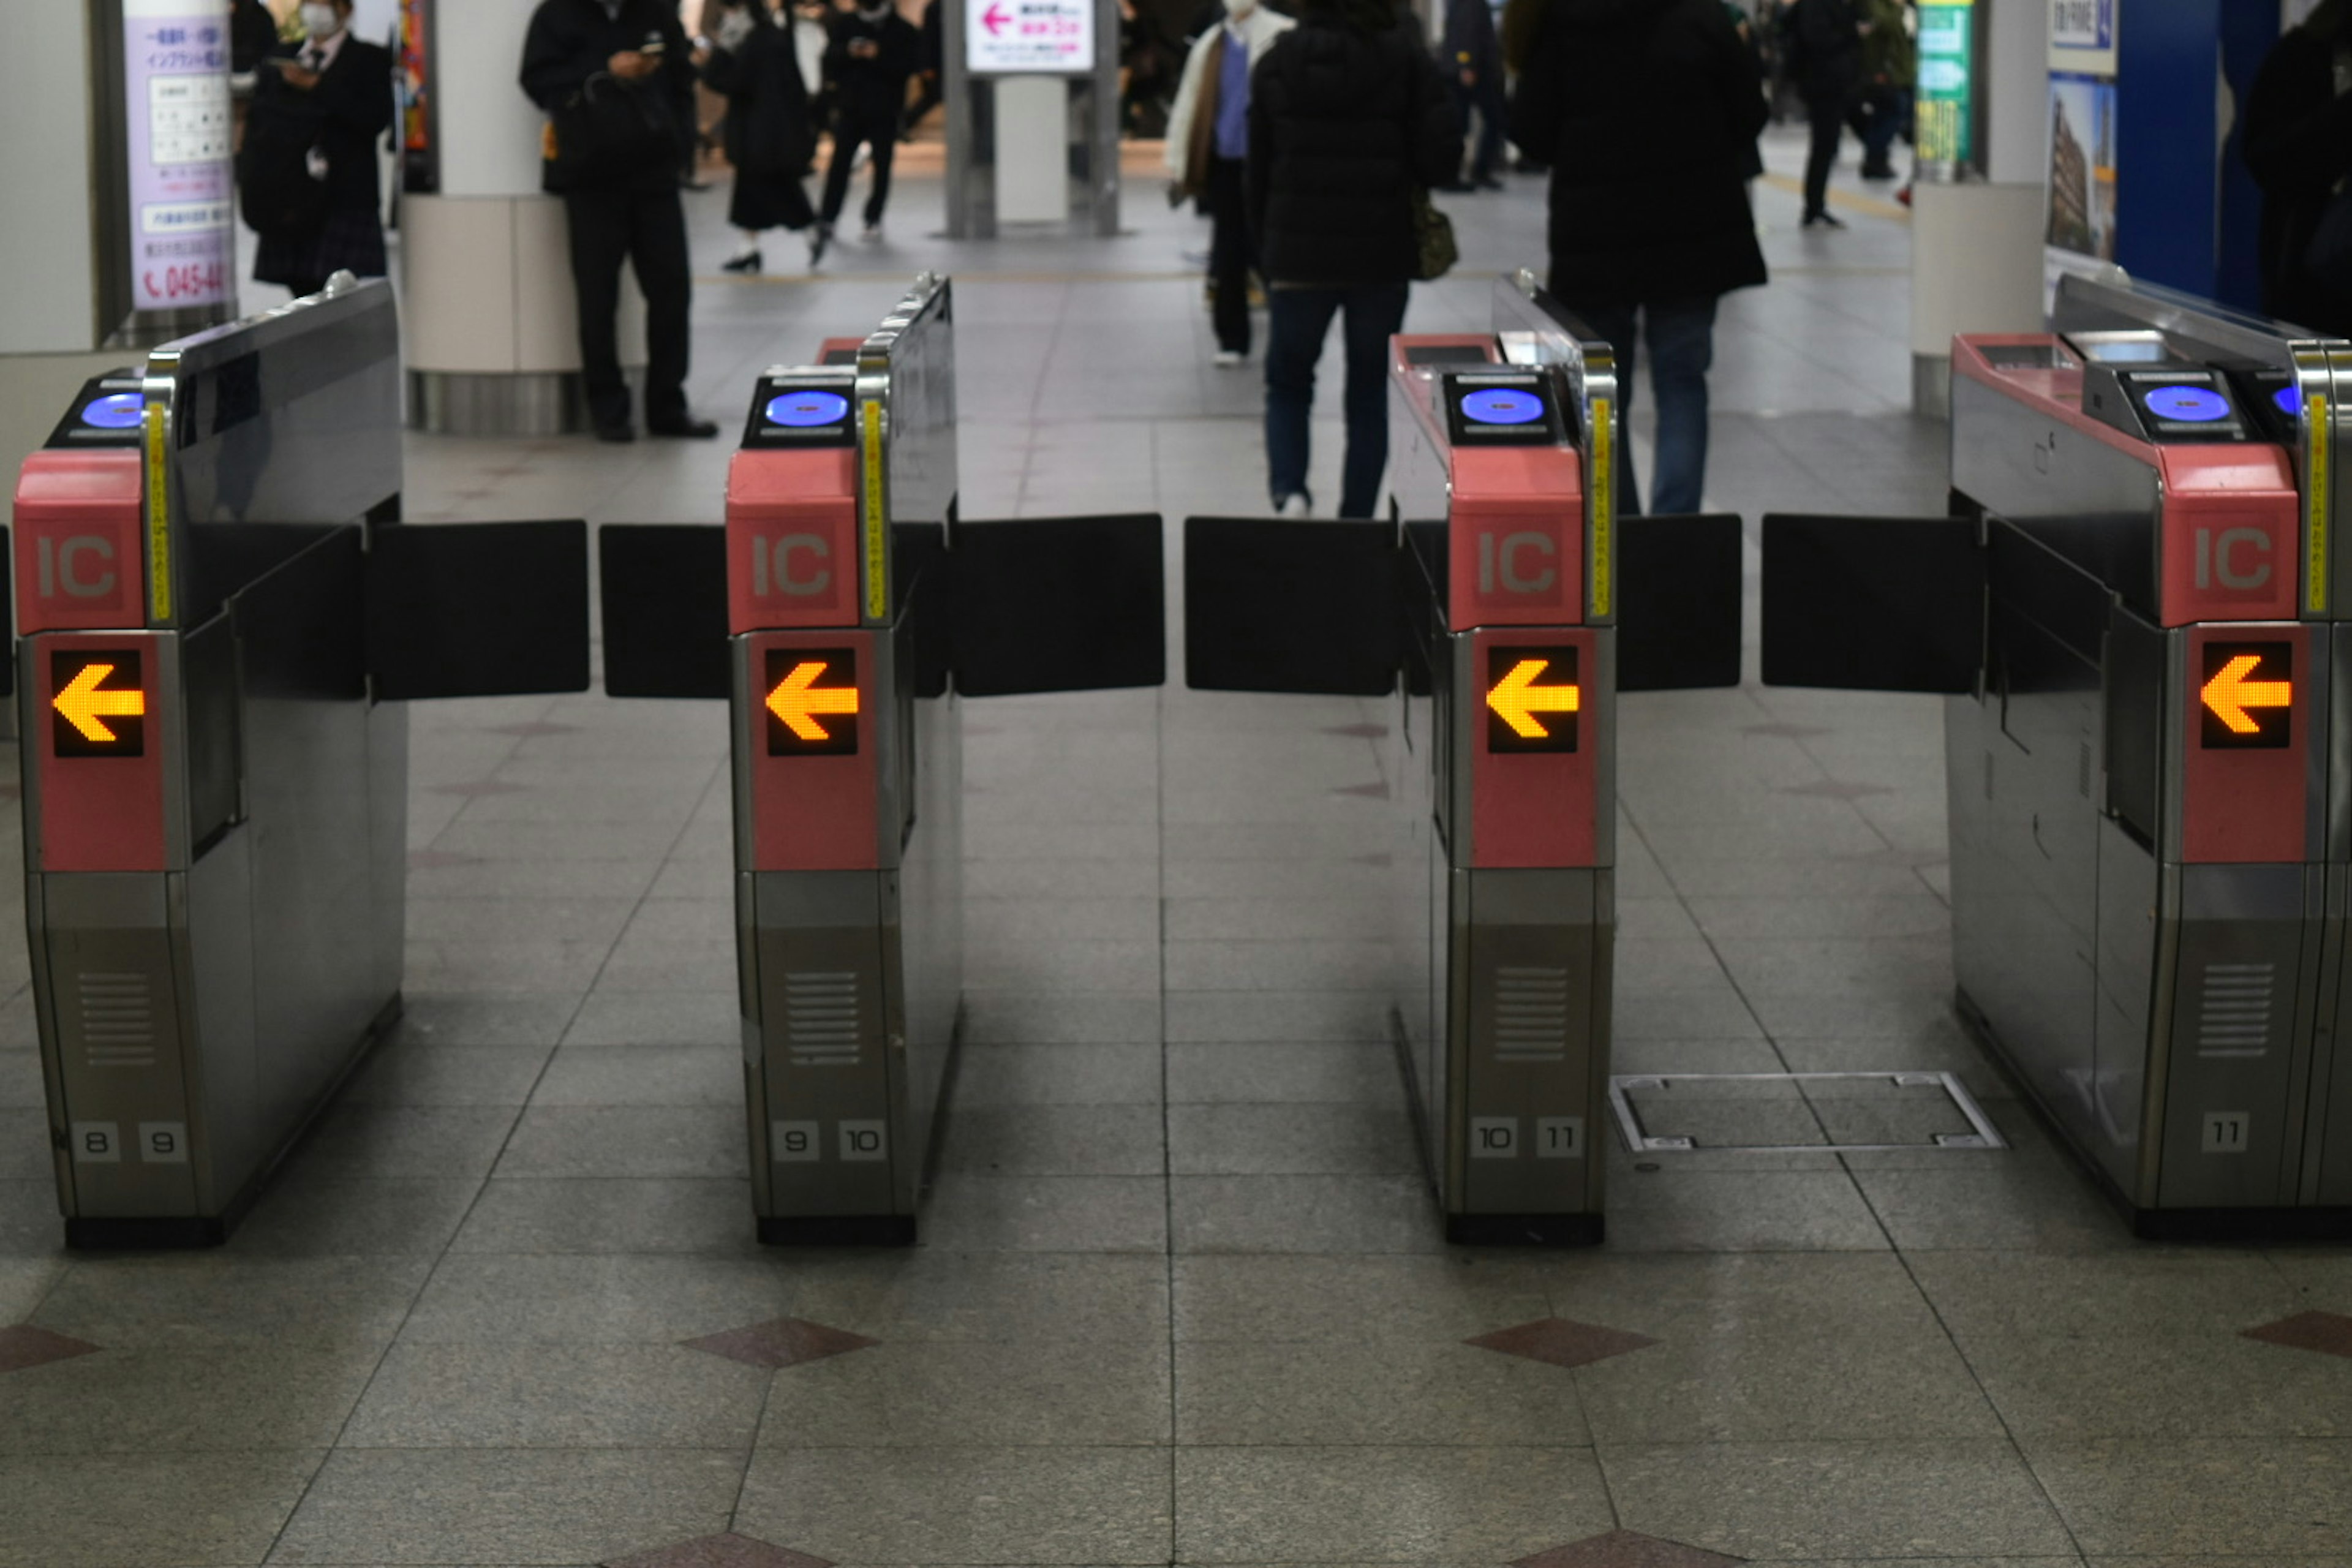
xmin=1183 ymin=517 xmax=1402 ymax=696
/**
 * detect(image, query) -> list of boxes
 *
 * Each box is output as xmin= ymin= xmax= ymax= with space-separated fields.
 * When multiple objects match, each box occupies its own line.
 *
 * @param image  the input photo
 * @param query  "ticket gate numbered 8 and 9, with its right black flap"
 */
xmin=14 ymin=275 xmax=588 ymax=1248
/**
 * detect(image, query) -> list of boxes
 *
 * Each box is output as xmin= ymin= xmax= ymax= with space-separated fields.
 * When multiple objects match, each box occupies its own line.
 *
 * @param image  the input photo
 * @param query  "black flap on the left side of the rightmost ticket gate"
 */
xmin=1762 ymin=513 xmax=1985 ymax=693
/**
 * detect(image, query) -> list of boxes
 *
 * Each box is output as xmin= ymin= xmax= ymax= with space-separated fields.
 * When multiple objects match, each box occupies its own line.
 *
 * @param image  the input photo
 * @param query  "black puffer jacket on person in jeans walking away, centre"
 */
xmin=1249 ymin=9 xmax=1463 ymax=284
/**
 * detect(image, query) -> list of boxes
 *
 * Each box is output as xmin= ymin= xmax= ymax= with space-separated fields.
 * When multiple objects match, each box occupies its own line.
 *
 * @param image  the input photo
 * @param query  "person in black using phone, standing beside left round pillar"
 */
xmin=522 ymin=0 xmax=720 ymax=442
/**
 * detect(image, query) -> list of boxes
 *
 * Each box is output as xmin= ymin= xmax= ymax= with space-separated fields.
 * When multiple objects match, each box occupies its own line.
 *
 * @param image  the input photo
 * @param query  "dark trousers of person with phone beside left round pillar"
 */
xmin=565 ymin=174 xmax=694 ymax=430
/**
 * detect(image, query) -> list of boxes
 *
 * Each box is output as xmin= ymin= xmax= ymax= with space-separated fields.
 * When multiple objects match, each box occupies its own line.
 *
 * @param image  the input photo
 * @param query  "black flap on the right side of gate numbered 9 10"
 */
xmin=946 ymin=513 xmax=1167 ymax=696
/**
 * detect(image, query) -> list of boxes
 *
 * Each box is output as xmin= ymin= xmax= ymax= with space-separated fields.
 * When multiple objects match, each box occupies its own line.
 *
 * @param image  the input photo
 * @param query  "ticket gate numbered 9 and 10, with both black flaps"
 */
xmin=597 ymin=275 xmax=1164 ymax=1243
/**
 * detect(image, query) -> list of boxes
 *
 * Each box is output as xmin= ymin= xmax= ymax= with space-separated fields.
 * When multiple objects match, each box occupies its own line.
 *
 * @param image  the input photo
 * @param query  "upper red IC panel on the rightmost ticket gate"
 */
xmin=2157 ymin=442 xmax=2302 ymax=625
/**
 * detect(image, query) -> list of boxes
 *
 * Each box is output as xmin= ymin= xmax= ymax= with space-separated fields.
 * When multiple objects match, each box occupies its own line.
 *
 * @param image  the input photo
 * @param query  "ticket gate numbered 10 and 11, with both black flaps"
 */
xmin=1185 ymin=273 xmax=1741 ymax=1243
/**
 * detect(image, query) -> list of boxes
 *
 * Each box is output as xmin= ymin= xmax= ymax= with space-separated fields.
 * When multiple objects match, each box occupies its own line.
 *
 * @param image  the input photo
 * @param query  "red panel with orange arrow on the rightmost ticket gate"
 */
xmin=2180 ymin=623 xmax=2312 ymax=865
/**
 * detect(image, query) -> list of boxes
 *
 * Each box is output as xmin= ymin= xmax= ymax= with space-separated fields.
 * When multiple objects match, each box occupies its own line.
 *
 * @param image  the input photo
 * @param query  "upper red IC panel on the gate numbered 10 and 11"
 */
xmin=1447 ymin=447 xmax=1585 ymax=630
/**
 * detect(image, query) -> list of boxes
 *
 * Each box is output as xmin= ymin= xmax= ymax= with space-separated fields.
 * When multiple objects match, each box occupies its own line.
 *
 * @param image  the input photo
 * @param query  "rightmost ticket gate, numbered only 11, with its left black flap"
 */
xmin=1764 ymin=277 xmax=2352 ymax=1237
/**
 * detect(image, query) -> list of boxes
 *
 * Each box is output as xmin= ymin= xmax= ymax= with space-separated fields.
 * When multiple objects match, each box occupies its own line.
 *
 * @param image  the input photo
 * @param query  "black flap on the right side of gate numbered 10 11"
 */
xmin=1616 ymin=513 xmax=1745 ymax=691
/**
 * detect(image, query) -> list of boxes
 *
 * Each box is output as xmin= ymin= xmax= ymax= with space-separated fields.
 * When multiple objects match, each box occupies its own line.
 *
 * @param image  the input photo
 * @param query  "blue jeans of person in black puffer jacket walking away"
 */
xmin=1265 ymin=282 xmax=1411 ymax=517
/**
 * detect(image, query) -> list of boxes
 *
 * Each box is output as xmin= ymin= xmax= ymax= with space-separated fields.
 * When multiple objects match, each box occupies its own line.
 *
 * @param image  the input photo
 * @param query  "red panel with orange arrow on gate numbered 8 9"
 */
xmin=26 ymin=632 xmax=169 ymax=872
